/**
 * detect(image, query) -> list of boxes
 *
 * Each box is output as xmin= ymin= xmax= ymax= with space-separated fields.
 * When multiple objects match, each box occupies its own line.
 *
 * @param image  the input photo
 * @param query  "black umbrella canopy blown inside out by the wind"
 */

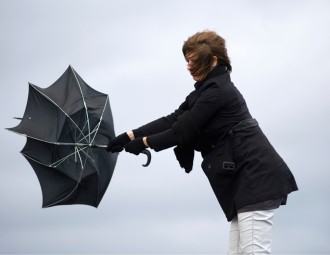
xmin=9 ymin=66 xmax=118 ymax=207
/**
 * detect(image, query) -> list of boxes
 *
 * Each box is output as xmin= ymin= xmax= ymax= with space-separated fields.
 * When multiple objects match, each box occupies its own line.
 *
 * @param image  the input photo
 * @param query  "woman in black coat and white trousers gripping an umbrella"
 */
xmin=108 ymin=31 xmax=298 ymax=254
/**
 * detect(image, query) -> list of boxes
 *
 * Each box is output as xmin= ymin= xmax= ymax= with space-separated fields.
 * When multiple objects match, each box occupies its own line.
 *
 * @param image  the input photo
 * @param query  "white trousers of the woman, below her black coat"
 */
xmin=227 ymin=210 xmax=275 ymax=255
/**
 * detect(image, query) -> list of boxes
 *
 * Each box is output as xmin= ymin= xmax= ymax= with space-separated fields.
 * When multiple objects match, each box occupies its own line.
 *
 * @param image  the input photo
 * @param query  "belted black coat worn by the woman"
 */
xmin=133 ymin=66 xmax=298 ymax=221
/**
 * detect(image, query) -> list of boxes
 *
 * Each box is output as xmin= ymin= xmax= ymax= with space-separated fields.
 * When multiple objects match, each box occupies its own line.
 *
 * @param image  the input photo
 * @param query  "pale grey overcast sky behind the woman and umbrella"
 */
xmin=0 ymin=0 xmax=330 ymax=254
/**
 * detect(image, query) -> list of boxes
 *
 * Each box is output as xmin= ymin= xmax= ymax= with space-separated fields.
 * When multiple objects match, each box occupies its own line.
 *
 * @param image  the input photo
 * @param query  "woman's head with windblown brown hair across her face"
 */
xmin=182 ymin=31 xmax=232 ymax=81
